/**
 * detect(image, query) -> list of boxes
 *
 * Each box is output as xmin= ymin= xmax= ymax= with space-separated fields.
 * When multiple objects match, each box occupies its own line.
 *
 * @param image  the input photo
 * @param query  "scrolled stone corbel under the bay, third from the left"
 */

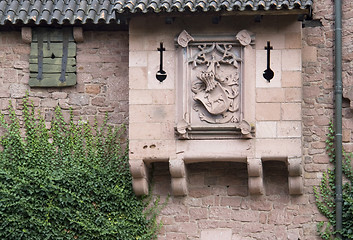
xmin=247 ymin=158 xmax=264 ymax=195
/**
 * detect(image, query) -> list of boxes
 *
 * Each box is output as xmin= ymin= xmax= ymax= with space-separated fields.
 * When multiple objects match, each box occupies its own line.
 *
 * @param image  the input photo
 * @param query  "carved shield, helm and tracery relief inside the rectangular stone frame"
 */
xmin=190 ymin=43 xmax=240 ymax=123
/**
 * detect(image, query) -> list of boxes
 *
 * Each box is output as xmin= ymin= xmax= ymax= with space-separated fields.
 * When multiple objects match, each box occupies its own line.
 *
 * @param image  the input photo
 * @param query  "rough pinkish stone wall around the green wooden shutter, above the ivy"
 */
xmin=0 ymin=31 xmax=128 ymax=128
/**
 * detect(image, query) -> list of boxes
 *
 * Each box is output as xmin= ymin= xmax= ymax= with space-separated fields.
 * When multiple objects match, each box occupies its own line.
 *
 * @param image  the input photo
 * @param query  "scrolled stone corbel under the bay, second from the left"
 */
xmin=169 ymin=155 xmax=188 ymax=196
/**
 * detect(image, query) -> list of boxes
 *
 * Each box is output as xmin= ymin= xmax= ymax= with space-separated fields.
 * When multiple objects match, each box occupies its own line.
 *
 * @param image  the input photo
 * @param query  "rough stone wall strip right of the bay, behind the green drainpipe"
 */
xmin=302 ymin=0 xmax=353 ymax=238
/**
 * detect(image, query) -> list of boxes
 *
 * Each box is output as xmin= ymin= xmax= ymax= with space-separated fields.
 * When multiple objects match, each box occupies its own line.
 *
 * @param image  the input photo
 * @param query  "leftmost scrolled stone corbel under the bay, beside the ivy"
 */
xmin=129 ymin=160 xmax=148 ymax=196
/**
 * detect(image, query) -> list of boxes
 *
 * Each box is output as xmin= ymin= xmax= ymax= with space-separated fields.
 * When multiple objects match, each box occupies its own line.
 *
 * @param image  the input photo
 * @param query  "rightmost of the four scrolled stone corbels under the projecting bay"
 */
xmin=287 ymin=158 xmax=303 ymax=195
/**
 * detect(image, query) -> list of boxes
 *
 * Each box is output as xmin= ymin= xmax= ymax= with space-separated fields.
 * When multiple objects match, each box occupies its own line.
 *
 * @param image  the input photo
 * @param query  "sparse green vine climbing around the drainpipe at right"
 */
xmin=314 ymin=123 xmax=353 ymax=240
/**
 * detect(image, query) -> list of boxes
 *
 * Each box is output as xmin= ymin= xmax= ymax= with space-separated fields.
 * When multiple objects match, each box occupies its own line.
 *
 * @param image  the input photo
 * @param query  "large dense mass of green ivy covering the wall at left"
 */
xmin=0 ymin=97 xmax=159 ymax=240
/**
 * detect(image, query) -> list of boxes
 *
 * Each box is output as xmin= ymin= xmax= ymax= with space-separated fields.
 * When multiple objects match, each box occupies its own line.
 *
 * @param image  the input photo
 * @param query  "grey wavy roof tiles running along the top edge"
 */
xmin=0 ymin=0 xmax=313 ymax=25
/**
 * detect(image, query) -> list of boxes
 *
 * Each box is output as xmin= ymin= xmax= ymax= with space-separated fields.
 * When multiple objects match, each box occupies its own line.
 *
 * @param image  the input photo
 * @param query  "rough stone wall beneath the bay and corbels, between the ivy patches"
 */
xmin=153 ymin=162 xmax=319 ymax=240
